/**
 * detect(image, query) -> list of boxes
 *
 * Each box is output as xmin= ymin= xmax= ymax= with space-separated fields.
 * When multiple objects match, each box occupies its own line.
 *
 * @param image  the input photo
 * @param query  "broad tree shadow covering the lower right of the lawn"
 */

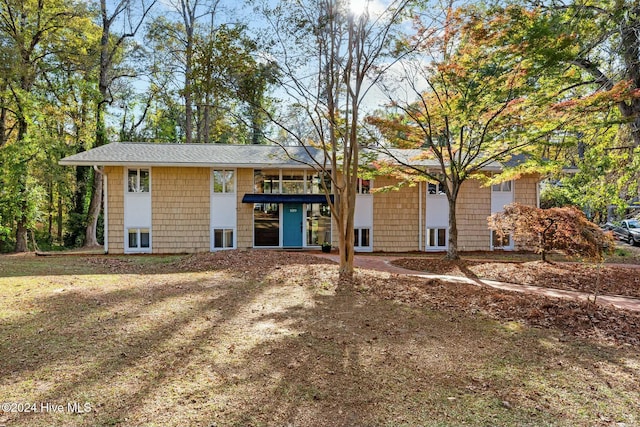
xmin=231 ymin=282 xmax=640 ymax=426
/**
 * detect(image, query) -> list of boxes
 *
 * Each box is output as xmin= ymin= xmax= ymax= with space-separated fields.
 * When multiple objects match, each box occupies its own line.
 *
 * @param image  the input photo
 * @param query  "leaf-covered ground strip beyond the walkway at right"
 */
xmin=392 ymin=258 xmax=640 ymax=298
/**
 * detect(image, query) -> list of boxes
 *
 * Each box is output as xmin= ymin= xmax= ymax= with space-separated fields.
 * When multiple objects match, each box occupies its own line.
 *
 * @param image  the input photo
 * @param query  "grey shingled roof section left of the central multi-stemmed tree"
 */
xmin=60 ymin=142 xmax=330 ymax=168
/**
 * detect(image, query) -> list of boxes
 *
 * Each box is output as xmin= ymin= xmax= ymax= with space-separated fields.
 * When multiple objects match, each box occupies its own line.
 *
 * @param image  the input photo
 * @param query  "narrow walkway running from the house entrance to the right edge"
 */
xmin=317 ymin=254 xmax=640 ymax=312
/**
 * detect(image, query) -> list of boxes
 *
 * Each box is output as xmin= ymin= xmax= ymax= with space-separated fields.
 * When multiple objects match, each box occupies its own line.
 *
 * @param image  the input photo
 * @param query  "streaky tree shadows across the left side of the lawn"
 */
xmin=0 ymin=270 xmax=270 ymax=425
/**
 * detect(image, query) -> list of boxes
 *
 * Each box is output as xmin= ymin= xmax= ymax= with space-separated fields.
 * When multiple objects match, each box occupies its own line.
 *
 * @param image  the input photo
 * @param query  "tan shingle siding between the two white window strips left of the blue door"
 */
xmin=151 ymin=167 xmax=211 ymax=254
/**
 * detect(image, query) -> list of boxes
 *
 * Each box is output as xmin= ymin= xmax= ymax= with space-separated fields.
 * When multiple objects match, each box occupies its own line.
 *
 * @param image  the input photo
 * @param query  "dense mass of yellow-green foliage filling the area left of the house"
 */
xmin=0 ymin=0 xmax=97 ymax=250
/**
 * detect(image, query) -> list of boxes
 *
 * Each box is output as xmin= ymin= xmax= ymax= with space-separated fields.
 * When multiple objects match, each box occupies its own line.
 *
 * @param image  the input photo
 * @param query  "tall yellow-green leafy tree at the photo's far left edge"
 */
xmin=0 ymin=0 xmax=86 ymax=252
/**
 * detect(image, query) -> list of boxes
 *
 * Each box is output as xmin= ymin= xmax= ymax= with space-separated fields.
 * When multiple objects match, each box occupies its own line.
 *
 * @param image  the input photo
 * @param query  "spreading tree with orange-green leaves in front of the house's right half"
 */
xmin=368 ymin=1 xmax=570 ymax=259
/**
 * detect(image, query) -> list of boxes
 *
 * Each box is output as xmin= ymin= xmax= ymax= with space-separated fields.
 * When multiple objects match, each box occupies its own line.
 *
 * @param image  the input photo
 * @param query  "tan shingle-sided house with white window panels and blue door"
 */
xmin=60 ymin=143 xmax=539 ymax=254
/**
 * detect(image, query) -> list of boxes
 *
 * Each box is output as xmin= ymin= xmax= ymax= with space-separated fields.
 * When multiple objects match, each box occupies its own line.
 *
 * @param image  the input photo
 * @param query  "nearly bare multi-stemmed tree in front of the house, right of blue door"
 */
xmin=258 ymin=0 xmax=408 ymax=280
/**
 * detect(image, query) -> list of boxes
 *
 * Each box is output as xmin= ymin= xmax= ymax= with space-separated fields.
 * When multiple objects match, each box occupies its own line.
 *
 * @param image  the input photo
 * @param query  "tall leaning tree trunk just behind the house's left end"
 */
xmin=84 ymin=0 xmax=157 ymax=247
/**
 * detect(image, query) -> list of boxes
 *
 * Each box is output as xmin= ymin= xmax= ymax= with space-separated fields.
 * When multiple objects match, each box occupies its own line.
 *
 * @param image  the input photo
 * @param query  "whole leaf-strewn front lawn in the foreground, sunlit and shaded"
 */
xmin=0 ymin=251 xmax=640 ymax=427
